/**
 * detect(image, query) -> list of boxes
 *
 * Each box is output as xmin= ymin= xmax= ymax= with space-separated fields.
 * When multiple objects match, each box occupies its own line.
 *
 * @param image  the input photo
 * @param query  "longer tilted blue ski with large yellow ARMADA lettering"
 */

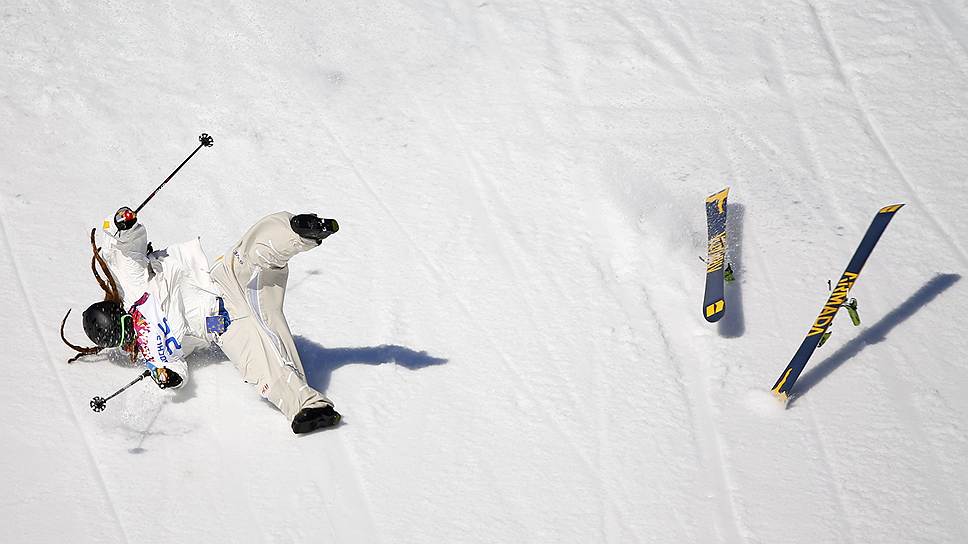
xmin=773 ymin=204 xmax=904 ymax=403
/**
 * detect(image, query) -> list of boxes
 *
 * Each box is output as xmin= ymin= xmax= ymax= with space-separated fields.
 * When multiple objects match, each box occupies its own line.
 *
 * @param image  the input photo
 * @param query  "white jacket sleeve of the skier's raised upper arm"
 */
xmin=99 ymin=223 xmax=148 ymax=306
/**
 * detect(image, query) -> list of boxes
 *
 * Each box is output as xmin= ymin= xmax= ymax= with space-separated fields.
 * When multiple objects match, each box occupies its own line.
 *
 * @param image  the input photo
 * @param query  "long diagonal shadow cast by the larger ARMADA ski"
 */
xmin=788 ymin=274 xmax=961 ymax=406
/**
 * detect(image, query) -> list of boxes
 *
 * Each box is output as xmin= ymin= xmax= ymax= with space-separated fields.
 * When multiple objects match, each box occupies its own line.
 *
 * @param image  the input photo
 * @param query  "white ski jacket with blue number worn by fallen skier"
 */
xmin=100 ymin=223 xmax=218 ymax=384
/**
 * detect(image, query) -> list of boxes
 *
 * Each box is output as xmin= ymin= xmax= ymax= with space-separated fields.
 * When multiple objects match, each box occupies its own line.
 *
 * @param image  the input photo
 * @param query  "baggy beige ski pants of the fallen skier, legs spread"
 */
xmin=212 ymin=212 xmax=332 ymax=420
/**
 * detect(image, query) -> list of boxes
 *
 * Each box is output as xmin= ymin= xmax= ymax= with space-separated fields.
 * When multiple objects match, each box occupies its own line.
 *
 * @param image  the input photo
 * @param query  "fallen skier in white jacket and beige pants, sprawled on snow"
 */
xmin=61 ymin=208 xmax=340 ymax=434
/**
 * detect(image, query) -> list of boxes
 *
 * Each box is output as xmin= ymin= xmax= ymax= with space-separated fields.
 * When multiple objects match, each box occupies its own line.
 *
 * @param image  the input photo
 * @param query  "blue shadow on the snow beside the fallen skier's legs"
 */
xmin=293 ymin=335 xmax=447 ymax=393
